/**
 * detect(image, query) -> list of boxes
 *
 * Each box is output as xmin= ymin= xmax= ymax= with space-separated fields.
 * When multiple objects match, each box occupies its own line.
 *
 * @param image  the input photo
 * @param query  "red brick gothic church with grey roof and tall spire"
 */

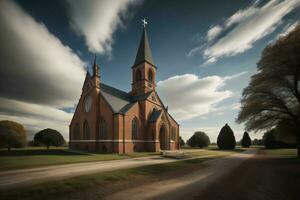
xmin=69 ymin=24 xmax=180 ymax=153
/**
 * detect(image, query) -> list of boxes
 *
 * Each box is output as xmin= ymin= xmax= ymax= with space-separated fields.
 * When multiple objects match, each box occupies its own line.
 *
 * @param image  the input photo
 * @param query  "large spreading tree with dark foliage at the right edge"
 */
xmin=237 ymin=25 xmax=300 ymax=158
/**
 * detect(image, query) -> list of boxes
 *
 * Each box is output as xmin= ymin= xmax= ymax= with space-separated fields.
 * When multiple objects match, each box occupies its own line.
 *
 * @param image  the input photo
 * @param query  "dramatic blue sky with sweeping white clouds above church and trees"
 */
xmin=0 ymin=0 xmax=300 ymax=142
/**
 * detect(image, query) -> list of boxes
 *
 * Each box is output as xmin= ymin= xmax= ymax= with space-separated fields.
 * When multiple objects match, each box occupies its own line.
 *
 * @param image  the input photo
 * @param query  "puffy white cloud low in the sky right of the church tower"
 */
xmin=157 ymin=72 xmax=246 ymax=121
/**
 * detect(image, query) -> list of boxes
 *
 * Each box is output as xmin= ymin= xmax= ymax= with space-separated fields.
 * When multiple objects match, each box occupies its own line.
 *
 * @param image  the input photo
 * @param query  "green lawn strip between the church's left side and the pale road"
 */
xmin=0 ymin=147 xmax=159 ymax=171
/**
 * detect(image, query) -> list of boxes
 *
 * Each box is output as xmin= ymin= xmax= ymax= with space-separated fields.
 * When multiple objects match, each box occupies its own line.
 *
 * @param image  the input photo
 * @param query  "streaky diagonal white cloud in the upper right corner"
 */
xmin=190 ymin=0 xmax=300 ymax=65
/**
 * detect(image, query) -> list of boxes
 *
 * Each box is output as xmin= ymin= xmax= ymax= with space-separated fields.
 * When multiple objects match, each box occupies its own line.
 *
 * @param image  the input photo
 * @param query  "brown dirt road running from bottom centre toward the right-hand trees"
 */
xmin=104 ymin=150 xmax=256 ymax=200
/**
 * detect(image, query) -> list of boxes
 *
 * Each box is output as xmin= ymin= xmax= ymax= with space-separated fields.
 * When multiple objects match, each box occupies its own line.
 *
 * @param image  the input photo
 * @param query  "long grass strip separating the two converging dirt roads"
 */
xmin=0 ymin=150 xmax=237 ymax=200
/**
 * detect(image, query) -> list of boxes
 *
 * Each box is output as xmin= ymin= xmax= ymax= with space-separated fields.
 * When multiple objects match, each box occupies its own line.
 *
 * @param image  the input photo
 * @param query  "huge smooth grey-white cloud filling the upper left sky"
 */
xmin=0 ymin=0 xmax=85 ymax=107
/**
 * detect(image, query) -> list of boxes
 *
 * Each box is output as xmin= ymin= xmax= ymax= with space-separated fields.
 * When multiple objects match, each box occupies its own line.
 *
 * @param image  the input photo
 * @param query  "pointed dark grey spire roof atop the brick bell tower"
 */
xmin=134 ymin=28 xmax=154 ymax=66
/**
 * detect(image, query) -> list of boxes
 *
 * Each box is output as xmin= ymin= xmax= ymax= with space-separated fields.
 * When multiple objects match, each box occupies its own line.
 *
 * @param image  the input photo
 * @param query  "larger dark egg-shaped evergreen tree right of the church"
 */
xmin=217 ymin=124 xmax=235 ymax=149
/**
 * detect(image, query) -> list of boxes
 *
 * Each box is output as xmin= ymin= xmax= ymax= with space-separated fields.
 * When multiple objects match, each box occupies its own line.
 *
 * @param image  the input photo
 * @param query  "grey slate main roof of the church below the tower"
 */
xmin=100 ymin=83 xmax=151 ymax=114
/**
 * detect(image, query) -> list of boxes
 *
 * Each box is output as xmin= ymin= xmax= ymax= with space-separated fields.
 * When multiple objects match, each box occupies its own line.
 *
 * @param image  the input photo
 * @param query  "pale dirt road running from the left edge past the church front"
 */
xmin=0 ymin=156 xmax=191 ymax=189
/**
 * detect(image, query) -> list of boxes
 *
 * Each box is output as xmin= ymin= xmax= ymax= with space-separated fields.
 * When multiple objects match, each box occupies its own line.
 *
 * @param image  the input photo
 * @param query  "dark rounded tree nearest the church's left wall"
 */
xmin=34 ymin=128 xmax=65 ymax=149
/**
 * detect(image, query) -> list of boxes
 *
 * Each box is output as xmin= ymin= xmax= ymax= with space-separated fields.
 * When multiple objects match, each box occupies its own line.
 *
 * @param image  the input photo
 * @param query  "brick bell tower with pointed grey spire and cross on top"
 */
xmin=131 ymin=19 xmax=156 ymax=95
